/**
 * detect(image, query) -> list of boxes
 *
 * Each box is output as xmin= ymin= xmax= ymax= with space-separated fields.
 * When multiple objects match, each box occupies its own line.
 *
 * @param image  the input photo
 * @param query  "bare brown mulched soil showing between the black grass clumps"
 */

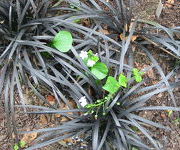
xmin=0 ymin=0 xmax=180 ymax=150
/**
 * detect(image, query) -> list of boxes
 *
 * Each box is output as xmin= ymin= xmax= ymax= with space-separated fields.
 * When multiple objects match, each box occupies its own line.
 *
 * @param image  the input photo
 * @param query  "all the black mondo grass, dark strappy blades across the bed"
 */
xmin=0 ymin=0 xmax=180 ymax=150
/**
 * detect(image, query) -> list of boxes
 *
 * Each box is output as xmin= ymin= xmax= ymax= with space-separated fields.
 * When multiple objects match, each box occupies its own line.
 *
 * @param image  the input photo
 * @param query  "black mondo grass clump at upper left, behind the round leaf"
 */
xmin=0 ymin=0 xmax=88 ymax=142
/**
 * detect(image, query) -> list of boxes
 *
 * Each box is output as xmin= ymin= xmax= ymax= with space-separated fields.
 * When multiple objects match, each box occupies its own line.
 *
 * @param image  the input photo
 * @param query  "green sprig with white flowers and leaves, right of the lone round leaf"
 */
xmin=79 ymin=50 xmax=143 ymax=119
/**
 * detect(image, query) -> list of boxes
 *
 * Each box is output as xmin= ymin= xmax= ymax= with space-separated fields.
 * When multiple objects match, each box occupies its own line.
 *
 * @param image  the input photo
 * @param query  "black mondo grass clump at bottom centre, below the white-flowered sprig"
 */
xmin=17 ymin=40 xmax=180 ymax=150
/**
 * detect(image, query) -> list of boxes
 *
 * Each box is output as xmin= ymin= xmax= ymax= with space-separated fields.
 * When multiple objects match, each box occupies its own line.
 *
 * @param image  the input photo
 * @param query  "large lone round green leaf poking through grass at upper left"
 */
xmin=52 ymin=31 xmax=73 ymax=52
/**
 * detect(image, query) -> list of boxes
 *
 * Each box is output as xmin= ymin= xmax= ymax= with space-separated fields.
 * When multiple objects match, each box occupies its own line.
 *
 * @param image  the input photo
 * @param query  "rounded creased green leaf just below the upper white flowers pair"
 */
xmin=91 ymin=62 xmax=108 ymax=80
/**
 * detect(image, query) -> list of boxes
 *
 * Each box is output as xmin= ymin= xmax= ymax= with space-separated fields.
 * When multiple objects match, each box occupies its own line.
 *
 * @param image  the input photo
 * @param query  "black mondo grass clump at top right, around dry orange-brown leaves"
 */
xmin=67 ymin=0 xmax=180 ymax=60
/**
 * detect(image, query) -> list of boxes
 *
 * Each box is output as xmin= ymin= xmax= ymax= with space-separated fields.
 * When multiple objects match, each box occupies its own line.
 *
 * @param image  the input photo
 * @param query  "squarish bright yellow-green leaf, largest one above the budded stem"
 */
xmin=103 ymin=76 xmax=120 ymax=94
